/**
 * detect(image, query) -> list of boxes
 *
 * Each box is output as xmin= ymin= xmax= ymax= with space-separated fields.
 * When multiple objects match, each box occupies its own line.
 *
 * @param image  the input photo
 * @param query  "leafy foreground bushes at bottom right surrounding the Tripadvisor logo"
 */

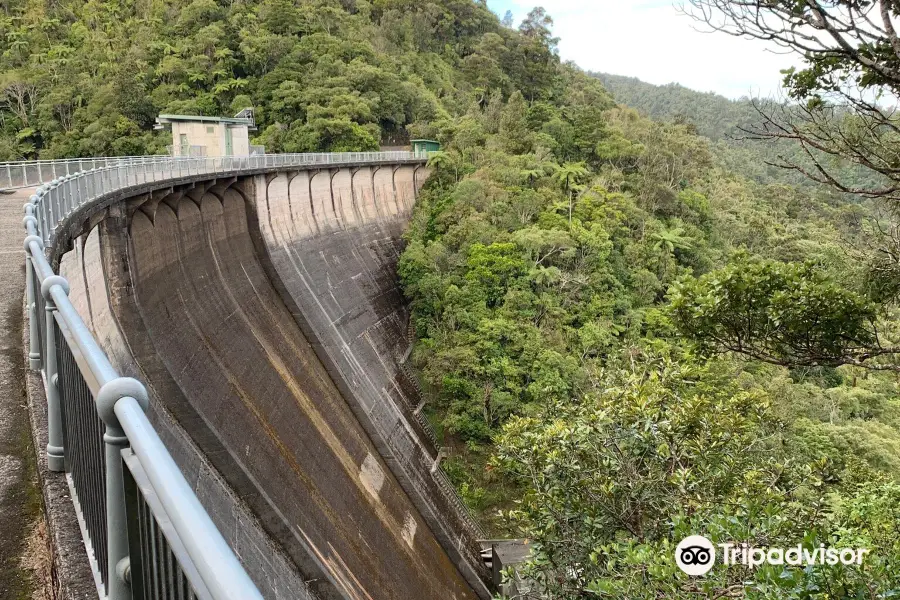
xmin=496 ymin=356 xmax=900 ymax=599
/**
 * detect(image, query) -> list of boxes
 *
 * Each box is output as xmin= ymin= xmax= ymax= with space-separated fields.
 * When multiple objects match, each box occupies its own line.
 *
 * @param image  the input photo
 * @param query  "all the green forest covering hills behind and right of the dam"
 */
xmin=0 ymin=0 xmax=900 ymax=600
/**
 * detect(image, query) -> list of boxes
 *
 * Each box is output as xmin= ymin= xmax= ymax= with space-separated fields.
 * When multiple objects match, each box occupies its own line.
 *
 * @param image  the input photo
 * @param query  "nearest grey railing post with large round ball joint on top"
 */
xmin=97 ymin=377 xmax=149 ymax=600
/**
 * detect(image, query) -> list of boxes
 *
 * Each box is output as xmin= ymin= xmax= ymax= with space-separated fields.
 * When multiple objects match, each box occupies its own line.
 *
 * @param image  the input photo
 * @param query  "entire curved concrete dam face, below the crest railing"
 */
xmin=46 ymin=161 xmax=490 ymax=600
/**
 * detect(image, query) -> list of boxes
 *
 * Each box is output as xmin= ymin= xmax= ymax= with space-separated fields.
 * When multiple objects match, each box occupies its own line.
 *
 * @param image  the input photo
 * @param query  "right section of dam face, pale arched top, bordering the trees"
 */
xmin=248 ymin=167 xmax=490 ymax=597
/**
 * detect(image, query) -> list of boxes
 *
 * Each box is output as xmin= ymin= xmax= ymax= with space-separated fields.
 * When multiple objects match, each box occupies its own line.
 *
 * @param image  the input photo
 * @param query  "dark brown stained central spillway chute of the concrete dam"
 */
xmin=131 ymin=184 xmax=482 ymax=598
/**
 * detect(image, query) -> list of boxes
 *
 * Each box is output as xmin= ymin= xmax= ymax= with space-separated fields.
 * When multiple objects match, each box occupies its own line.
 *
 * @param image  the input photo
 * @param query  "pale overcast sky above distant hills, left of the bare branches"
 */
xmin=488 ymin=0 xmax=797 ymax=98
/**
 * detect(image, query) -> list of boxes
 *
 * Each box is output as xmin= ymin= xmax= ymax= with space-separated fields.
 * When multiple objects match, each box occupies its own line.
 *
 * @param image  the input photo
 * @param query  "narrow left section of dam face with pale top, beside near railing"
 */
xmin=60 ymin=219 xmax=328 ymax=600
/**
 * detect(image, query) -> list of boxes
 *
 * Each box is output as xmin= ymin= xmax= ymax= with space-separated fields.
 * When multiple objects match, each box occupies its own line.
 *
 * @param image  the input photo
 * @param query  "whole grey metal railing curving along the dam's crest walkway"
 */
xmin=20 ymin=152 xmax=425 ymax=600
